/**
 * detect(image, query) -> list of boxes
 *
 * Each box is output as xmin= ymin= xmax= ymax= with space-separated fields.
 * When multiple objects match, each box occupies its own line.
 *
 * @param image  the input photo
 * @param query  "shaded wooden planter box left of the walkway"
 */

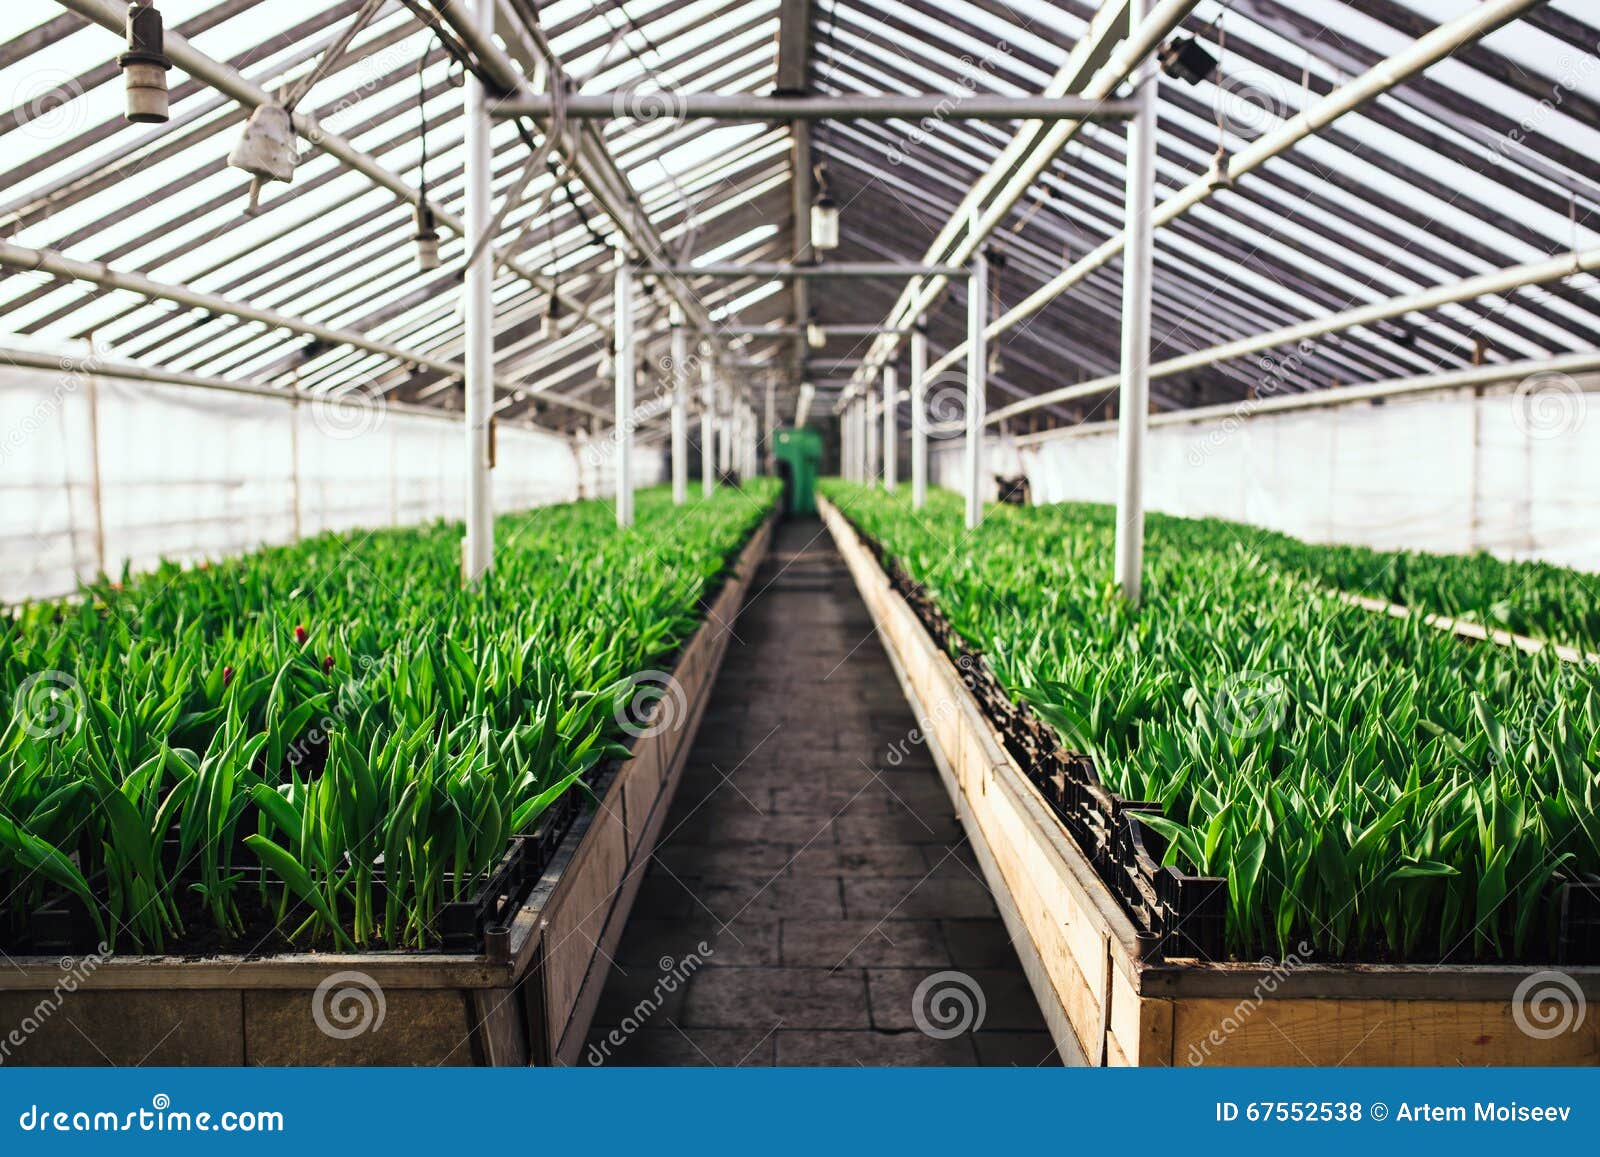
xmin=0 ymin=518 xmax=774 ymax=1066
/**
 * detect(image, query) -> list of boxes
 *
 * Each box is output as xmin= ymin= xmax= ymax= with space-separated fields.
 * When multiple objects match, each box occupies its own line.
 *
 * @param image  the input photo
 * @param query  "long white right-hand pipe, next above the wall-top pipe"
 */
xmin=979 ymin=248 xmax=1600 ymax=424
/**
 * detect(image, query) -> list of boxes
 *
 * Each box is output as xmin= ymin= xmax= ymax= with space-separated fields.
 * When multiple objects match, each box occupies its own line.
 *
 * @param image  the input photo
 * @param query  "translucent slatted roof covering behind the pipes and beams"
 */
xmin=0 ymin=0 xmax=1600 ymax=435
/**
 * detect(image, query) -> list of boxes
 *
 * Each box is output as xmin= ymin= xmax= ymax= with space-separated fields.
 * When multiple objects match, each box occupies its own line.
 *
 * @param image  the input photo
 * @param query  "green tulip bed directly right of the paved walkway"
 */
xmin=826 ymin=482 xmax=1600 ymax=960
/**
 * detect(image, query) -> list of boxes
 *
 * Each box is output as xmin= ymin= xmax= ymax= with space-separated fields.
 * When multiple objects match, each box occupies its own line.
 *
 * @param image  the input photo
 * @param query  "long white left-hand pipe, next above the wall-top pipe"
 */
xmin=0 ymin=242 xmax=610 ymax=418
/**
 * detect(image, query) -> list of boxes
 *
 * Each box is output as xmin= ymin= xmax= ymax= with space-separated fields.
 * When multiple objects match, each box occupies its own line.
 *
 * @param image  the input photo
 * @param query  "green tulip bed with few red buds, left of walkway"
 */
xmin=0 ymin=480 xmax=776 ymax=951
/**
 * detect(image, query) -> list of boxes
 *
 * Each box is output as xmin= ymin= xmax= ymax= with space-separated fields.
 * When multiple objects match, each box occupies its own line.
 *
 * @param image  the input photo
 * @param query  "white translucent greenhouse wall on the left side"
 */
xmin=0 ymin=368 xmax=664 ymax=602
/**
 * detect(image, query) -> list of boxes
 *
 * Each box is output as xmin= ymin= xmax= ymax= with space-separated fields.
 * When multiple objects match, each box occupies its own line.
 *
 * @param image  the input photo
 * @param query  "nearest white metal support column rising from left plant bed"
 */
xmin=461 ymin=0 xmax=494 ymax=586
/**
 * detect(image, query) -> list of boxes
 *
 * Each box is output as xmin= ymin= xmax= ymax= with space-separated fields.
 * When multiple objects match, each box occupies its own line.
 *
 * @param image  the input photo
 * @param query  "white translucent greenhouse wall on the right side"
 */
xmin=930 ymin=390 xmax=1600 ymax=571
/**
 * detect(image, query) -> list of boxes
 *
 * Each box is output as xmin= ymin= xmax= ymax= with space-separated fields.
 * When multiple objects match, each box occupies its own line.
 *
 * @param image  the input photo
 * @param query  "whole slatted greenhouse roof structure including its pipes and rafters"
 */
xmin=0 ymin=0 xmax=1600 ymax=430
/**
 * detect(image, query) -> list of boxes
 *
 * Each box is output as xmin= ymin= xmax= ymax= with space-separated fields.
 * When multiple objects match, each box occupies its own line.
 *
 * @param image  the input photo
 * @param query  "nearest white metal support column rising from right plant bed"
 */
xmin=1115 ymin=0 xmax=1158 ymax=607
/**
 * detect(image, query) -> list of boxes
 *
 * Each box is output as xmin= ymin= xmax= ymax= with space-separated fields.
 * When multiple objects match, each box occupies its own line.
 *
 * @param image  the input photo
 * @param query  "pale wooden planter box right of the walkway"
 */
xmin=821 ymin=501 xmax=1600 ymax=1066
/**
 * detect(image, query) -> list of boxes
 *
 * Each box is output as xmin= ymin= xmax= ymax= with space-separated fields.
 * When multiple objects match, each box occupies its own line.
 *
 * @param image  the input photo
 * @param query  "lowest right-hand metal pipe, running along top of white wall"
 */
xmin=1016 ymin=354 xmax=1600 ymax=445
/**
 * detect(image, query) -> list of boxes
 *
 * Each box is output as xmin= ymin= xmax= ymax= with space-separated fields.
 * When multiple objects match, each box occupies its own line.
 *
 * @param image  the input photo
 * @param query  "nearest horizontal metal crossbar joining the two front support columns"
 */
xmin=494 ymin=90 xmax=1133 ymax=122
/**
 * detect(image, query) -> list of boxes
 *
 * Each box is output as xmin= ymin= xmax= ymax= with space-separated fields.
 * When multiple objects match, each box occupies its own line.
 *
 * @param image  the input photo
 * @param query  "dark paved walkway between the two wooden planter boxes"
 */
xmin=582 ymin=520 xmax=1059 ymax=1066
